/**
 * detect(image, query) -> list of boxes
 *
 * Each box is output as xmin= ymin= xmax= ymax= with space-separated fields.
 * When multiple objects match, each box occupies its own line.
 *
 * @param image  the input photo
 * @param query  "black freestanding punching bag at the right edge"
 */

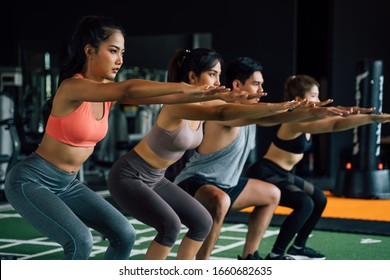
xmin=334 ymin=60 xmax=390 ymax=198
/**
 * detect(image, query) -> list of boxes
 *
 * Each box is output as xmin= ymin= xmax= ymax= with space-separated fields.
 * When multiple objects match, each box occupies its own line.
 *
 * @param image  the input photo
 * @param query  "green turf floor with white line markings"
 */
xmin=0 ymin=209 xmax=390 ymax=260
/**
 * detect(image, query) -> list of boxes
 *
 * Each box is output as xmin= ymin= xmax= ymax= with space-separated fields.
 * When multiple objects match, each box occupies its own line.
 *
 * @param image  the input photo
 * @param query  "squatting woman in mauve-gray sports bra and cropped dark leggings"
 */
xmin=108 ymin=48 xmax=300 ymax=259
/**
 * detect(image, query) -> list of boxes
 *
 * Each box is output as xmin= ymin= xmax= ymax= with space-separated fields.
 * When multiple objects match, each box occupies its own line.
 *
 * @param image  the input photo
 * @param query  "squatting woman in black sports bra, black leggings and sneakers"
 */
xmin=249 ymin=75 xmax=390 ymax=260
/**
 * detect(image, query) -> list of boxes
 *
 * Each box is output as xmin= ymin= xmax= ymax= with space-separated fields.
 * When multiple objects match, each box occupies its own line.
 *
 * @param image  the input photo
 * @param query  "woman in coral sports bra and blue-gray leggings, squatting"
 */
xmin=5 ymin=16 xmax=230 ymax=260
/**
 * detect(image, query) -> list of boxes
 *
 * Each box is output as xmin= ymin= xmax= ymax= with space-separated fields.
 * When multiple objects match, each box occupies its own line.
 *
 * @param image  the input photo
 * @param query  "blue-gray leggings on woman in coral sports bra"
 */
xmin=5 ymin=153 xmax=135 ymax=260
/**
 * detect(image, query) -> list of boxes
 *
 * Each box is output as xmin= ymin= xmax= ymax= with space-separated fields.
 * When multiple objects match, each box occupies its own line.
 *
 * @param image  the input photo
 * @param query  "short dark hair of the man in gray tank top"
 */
xmin=225 ymin=57 xmax=263 ymax=87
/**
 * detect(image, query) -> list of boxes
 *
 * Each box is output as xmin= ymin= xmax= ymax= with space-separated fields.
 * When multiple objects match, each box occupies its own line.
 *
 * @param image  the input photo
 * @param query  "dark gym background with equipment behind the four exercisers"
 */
xmin=0 ymin=0 xmax=390 ymax=201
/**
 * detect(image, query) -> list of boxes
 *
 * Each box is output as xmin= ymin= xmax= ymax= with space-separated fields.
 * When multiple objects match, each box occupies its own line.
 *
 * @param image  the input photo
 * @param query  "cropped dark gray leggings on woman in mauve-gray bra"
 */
xmin=108 ymin=150 xmax=212 ymax=247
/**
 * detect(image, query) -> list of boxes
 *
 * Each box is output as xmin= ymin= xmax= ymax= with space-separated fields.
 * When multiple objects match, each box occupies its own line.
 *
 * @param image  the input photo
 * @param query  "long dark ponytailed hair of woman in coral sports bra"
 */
xmin=58 ymin=15 xmax=125 ymax=86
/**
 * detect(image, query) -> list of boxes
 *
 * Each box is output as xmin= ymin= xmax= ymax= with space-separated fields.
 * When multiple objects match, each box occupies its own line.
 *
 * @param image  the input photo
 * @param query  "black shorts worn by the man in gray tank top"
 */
xmin=178 ymin=175 xmax=248 ymax=211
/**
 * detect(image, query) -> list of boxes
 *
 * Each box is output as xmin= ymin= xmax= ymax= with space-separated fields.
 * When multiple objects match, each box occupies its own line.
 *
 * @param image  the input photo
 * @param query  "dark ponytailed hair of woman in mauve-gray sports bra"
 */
xmin=167 ymin=48 xmax=223 ymax=83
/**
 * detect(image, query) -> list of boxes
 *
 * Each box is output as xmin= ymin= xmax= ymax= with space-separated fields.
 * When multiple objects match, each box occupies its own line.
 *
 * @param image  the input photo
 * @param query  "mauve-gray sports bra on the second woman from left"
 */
xmin=145 ymin=120 xmax=203 ymax=160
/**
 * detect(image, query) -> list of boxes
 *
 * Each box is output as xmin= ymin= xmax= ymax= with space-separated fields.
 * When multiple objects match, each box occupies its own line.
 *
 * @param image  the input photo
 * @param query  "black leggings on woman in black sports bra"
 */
xmin=248 ymin=159 xmax=327 ymax=254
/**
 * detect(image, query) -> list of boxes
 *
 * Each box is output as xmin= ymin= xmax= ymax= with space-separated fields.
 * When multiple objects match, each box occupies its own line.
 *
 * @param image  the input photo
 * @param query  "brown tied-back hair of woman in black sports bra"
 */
xmin=284 ymin=75 xmax=320 ymax=101
